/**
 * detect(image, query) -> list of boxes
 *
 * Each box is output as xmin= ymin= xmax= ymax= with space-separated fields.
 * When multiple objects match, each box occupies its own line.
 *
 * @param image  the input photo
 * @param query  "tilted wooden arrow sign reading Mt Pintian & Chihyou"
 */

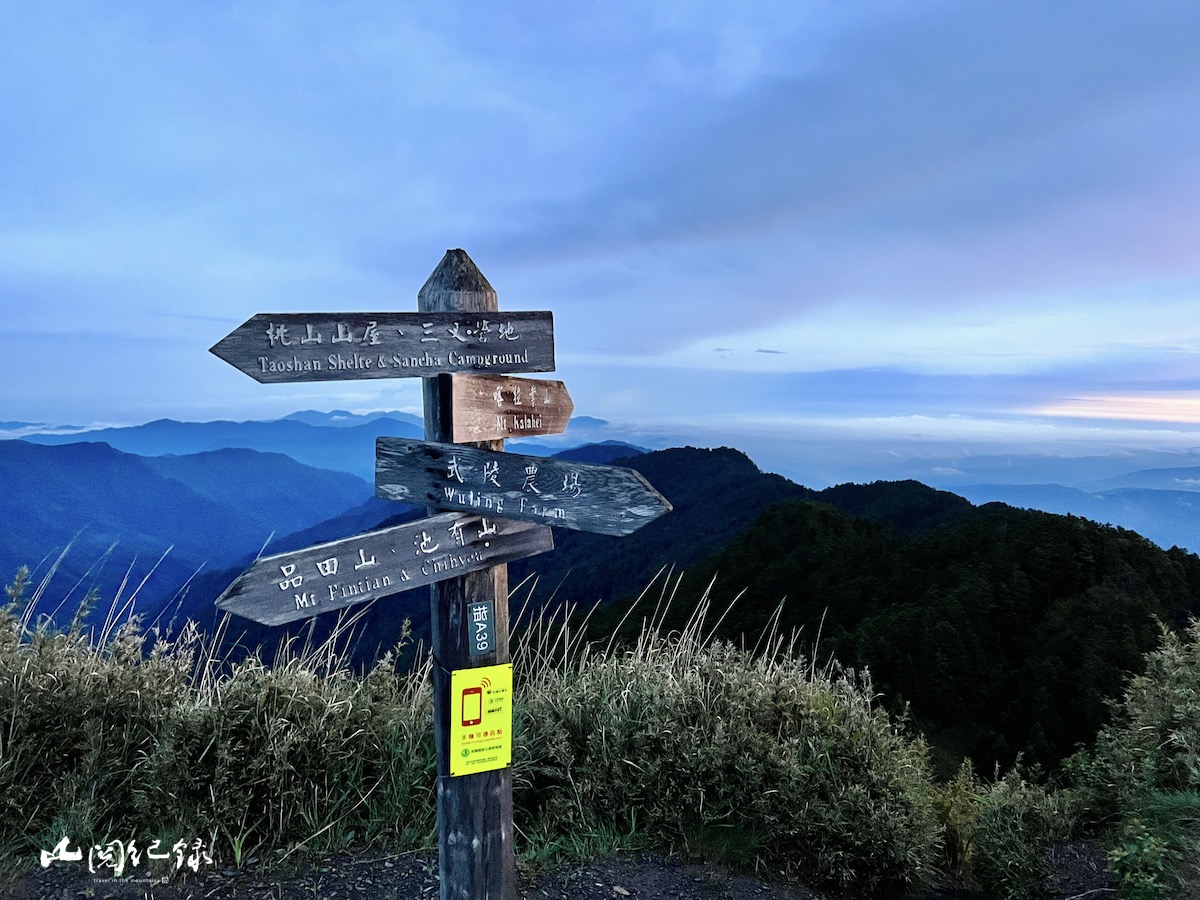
xmin=216 ymin=512 xmax=554 ymax=625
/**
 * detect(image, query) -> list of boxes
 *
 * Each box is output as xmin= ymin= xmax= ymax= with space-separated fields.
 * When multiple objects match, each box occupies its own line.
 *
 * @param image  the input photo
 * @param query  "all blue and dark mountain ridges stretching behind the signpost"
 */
xmin=0 ymin=414 xmax=1200 ymax=764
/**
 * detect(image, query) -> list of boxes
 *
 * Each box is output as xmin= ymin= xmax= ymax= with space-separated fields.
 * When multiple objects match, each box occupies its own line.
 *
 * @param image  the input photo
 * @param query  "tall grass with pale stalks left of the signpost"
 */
xmin=0 ymin=566 xmax=436 ymax=863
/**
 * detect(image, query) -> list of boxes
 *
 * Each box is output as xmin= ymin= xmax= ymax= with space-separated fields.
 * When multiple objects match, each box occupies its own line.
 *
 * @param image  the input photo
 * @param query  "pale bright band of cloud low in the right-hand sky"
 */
xmin=658 ymin=289 xmax=1200 ymax=381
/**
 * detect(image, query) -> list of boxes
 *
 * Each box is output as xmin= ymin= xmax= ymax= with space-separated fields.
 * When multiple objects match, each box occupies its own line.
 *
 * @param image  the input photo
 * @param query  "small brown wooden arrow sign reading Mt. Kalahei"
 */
xmin=451 ymin=374 xmax=575 ymax=444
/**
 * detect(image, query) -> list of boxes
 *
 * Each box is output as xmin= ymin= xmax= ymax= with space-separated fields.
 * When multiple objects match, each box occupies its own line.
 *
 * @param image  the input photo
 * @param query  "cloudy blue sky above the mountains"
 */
xmin=0 ymin=0 xmax=1200 ymax=481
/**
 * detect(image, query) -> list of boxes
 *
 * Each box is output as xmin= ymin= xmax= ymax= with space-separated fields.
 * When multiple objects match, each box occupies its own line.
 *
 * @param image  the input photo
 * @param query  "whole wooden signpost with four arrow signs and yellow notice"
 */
xmin=212 ymin=250 xmax=671 ymax=900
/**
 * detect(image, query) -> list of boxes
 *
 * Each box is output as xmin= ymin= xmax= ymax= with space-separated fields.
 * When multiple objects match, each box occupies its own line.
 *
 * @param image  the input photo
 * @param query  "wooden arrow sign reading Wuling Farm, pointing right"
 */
xmin=376 ymin=438 xmax=671 ymax=534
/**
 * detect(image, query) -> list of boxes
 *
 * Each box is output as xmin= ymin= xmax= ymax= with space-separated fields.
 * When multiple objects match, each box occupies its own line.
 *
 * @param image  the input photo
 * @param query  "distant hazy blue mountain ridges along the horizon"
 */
xmin=11 ymin=410 xmax=1200 ymax=552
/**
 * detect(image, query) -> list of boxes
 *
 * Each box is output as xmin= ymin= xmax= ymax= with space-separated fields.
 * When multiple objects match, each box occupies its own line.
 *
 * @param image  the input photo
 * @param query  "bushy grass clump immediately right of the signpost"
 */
xmin=515 ymin=595 xmax=941 ymax=894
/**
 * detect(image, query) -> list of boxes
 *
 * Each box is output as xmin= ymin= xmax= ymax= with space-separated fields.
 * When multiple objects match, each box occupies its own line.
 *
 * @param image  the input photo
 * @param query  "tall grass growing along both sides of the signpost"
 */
xmin=0 ymin=566 xmax=942 ymax=895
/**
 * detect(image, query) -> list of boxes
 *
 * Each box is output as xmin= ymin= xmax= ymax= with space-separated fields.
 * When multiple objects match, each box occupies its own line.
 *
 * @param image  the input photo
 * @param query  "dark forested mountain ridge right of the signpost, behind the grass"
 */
xmin=542 ymin=449 xmax=1200 ymax=773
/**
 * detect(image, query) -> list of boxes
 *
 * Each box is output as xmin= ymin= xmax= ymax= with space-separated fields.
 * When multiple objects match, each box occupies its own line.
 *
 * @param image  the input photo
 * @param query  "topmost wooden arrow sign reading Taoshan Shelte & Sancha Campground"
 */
xmin=210 ymin=311 xmax=554 ymax=383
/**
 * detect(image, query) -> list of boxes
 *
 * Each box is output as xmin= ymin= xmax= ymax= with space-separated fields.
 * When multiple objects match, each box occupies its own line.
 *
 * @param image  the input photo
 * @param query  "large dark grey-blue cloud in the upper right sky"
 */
xmin=494 ymin=2 xmax=1200 ymax=247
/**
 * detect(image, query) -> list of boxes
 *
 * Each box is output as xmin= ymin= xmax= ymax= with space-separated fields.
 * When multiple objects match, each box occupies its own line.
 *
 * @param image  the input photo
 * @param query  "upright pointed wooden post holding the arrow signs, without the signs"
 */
xmin=416 ymin=250 xmax=516 ymax=900
